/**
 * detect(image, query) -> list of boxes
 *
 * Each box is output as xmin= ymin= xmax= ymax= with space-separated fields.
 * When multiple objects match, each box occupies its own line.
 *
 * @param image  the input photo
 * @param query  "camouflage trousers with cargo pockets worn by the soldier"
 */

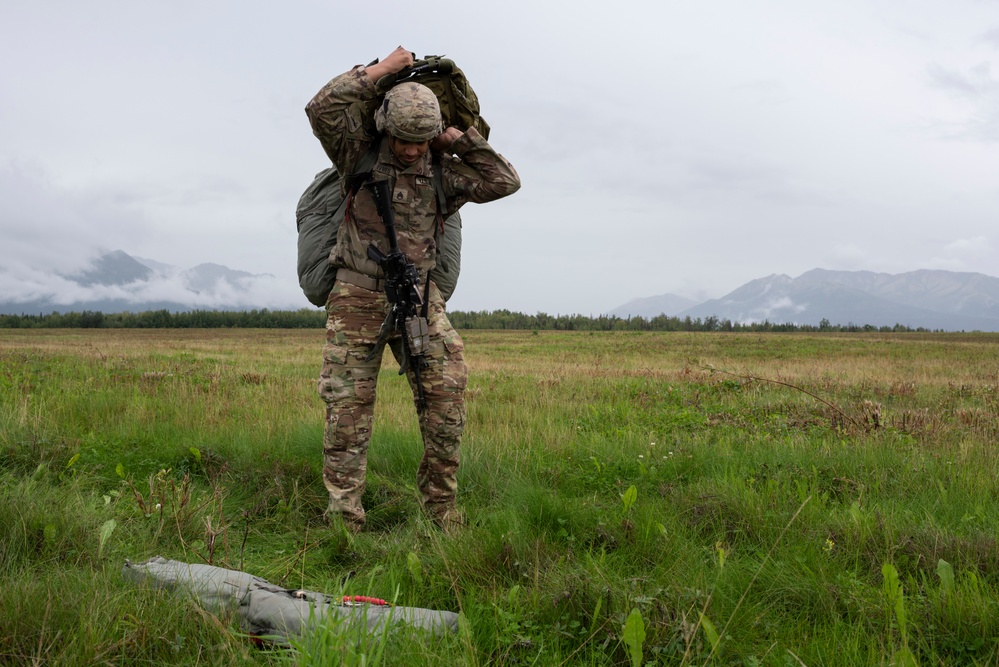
xmin=319 ymin=280 xmax=468 ymax=530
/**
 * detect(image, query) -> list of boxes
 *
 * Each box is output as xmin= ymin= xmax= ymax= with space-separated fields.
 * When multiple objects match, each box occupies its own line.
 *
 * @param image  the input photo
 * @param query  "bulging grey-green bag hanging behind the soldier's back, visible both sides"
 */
xmin=295 ymin=167 xmax=461 ymax=306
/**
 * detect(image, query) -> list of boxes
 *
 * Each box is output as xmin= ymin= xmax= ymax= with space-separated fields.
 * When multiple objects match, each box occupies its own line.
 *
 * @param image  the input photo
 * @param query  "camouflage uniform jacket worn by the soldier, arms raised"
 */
xmin=305 ymin=66 xmax=520 ymax=276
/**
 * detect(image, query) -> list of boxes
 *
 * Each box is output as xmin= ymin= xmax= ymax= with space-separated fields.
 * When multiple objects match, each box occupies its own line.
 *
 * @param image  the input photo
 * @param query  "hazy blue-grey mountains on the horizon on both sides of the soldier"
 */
xmin=0 ymin=250 xmax=999 ymax=331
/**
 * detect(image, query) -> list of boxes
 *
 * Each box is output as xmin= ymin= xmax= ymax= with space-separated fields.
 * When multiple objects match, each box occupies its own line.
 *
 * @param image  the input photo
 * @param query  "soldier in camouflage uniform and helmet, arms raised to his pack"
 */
xmin=305 ymin=46 xmax=520 ymax=532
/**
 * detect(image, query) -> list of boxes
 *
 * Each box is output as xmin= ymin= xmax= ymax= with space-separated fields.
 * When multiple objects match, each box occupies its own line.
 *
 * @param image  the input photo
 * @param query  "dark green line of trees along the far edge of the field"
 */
xmin=0 ymin=308 xmax=929 ymax=332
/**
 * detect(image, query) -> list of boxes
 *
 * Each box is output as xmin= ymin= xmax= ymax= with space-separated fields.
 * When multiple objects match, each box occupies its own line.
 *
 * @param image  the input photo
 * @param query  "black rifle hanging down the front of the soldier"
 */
xmin=365 ymin=179 xmax=430 ymax=412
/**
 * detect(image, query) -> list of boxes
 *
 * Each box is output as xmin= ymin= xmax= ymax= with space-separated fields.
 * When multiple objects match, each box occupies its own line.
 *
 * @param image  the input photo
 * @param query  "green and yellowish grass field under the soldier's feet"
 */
xmin=0 ymin=329 xmax=999 ymax=666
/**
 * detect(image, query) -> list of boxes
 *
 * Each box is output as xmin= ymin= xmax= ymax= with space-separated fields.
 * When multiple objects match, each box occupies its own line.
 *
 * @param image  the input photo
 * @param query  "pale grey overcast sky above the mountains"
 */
xmin=0 ymin=0 xmax=999 ymax=314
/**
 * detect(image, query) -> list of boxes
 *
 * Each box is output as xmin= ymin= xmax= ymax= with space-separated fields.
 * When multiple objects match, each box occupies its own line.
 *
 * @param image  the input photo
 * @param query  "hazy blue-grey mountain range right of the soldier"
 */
xmin=609 ymin=269 xmax=999 ymax=331
